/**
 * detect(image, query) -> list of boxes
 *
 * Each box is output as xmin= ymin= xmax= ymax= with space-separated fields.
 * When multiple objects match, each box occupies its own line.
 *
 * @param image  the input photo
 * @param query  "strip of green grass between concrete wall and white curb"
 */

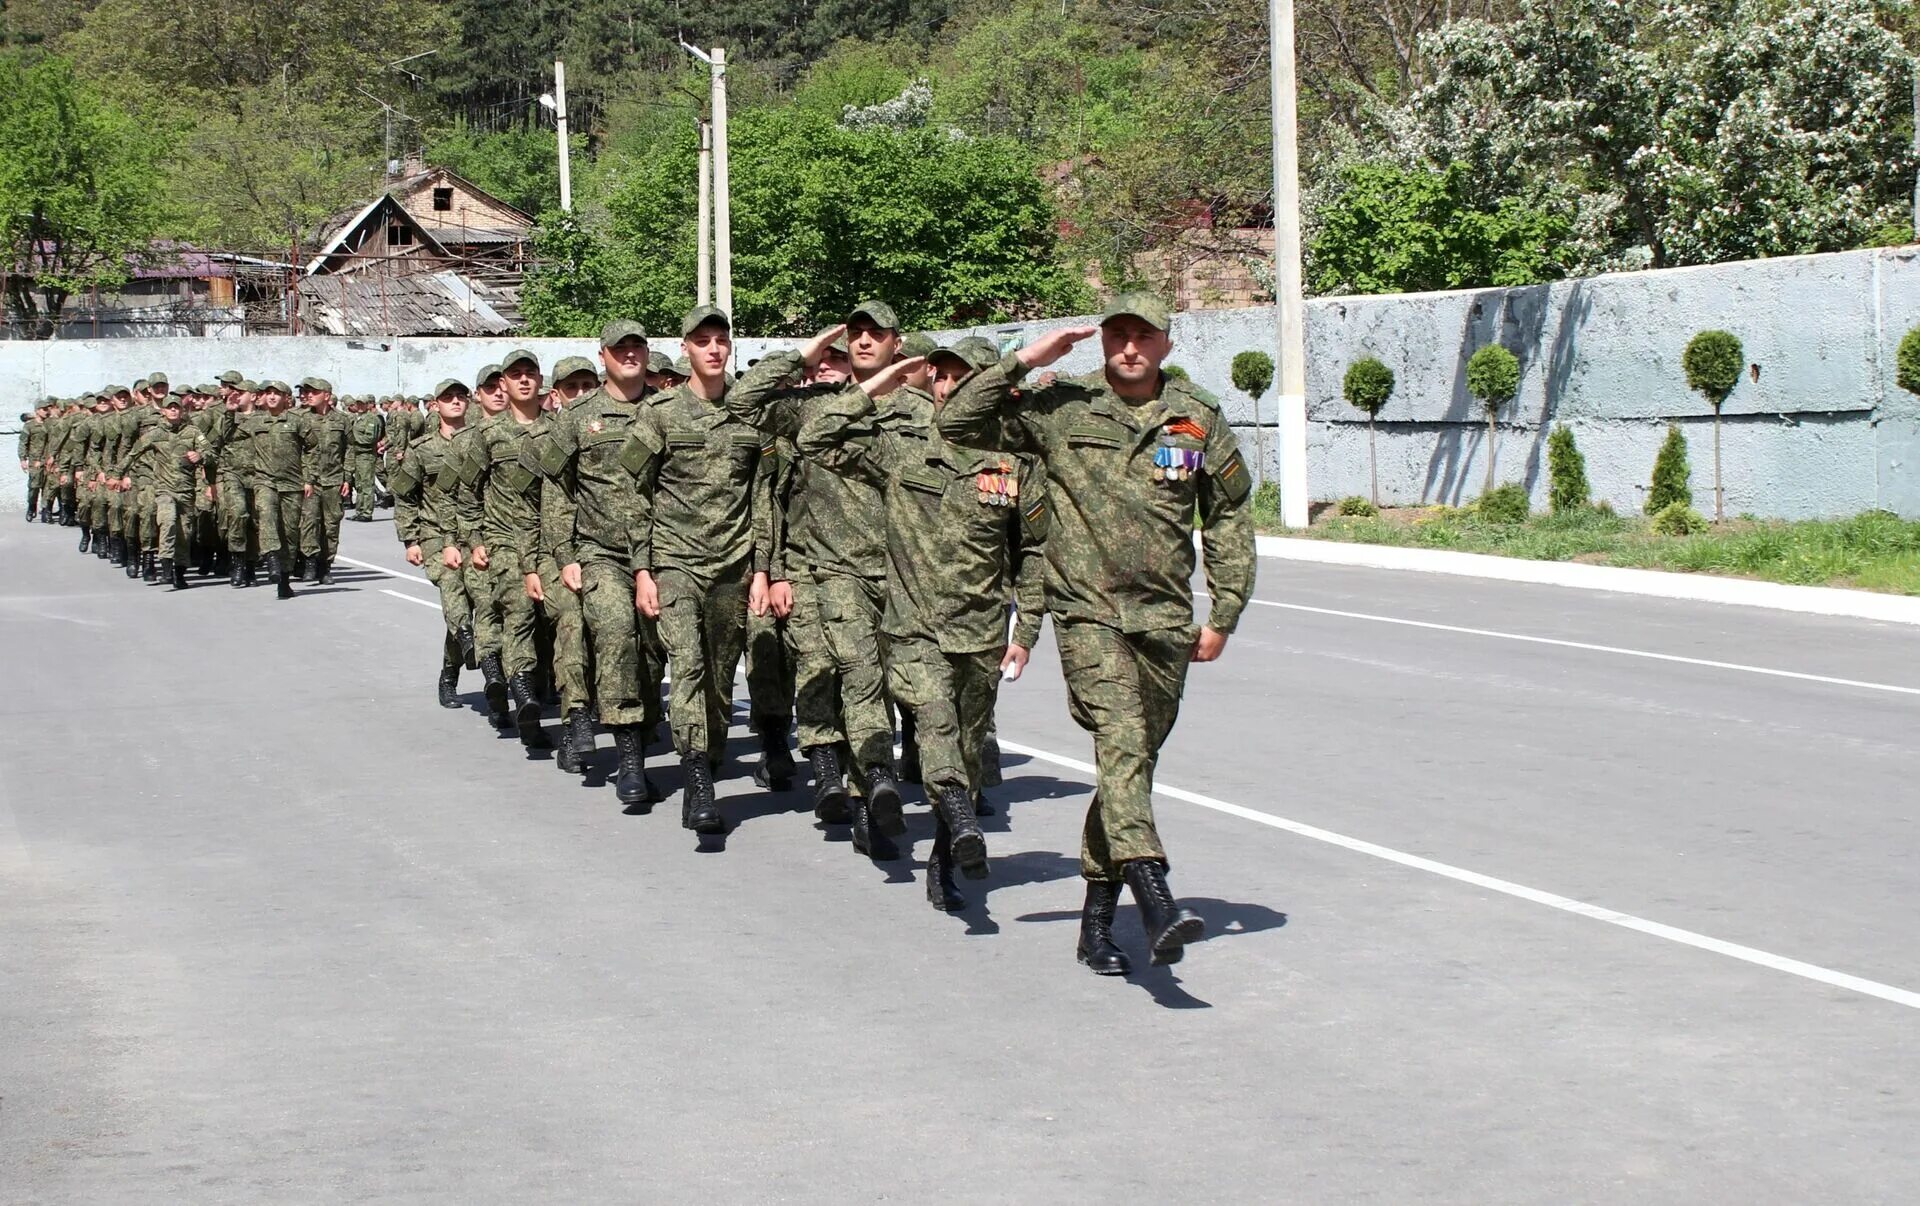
xmin=1254 ymin=492 xmax=1920 ymax=595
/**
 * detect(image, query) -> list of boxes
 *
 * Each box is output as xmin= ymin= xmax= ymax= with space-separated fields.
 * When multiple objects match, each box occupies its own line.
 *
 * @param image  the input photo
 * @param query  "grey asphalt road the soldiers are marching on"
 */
xmin=0 ymin=515 xmax=1920 ymax=1204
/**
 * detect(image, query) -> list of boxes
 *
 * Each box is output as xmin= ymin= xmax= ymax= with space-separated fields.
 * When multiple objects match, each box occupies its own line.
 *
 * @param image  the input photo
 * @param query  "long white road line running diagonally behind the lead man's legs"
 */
xmin=1000 ymin=737 xmax=1920 ymax=1008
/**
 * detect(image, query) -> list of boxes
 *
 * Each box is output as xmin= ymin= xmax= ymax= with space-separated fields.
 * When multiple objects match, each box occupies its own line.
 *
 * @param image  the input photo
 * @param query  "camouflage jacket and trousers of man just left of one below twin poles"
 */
xmin=522 ymin=388 xmax=664 ymax=730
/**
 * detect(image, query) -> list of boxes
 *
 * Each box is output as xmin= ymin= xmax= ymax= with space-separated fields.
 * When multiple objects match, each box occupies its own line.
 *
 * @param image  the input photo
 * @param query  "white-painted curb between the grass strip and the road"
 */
xmin=1256 ymin=536 xmax=1920 ymax=624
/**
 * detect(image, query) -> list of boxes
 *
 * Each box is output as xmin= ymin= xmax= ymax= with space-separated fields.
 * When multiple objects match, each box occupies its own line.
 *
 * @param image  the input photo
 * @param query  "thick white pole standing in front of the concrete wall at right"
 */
xmin=1267 ymin=0 xmax=1308 ymax=528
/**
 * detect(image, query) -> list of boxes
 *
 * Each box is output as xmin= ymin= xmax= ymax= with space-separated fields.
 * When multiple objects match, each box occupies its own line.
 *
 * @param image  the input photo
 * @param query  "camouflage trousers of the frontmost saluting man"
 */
xmin=1059 ymin=616 xmax=1198 ymax=881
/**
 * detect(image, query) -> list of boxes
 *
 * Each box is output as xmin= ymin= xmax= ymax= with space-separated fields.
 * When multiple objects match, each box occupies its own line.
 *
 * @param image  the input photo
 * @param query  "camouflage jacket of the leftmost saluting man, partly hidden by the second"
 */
xmin=728 ymin=350 xmax=895 ymax=578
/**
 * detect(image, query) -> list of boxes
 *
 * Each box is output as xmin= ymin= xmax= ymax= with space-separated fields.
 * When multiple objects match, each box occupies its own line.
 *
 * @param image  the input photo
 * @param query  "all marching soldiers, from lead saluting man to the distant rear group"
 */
xmin=21 ymin=294 xmax=1254 ymax=976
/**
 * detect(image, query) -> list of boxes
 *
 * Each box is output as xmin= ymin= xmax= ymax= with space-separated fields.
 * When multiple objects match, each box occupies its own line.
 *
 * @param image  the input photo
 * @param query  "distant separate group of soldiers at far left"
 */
xmin=19 ymin=373 xmax=408 ymax=599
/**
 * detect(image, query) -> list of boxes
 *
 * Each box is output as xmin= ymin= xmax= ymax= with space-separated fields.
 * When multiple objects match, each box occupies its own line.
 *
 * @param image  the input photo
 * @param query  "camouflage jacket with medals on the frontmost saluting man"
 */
xmin=939 ymin=355 xmax=1254 ymax=632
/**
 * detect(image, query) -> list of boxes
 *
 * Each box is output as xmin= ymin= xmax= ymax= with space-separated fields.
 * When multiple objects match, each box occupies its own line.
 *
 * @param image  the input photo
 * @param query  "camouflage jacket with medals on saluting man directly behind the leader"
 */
xmin=795 ymin=388 xmax=1050 ymax=653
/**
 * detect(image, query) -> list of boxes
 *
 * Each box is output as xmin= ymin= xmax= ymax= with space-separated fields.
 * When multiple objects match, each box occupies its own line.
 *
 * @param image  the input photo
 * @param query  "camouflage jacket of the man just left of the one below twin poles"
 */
xmin=520 ymin=388 xmax=649 ymax=572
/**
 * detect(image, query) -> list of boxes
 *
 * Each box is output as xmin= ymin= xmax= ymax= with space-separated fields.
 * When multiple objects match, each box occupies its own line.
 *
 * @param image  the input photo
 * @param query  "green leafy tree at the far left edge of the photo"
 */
xmin=0 ymin=52 xmax=161 ymax=340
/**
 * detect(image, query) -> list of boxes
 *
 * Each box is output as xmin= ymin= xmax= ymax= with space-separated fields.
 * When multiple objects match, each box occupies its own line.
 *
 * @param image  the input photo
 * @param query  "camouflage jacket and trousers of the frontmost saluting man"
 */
xmin=939 ymin=355 xmax=1254 ymax=881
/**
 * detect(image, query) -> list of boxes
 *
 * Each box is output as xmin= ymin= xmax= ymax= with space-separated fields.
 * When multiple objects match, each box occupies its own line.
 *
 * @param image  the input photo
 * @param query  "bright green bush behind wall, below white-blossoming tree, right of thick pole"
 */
xmin=1309 ymin=163 xmax=1569 ymax=294
